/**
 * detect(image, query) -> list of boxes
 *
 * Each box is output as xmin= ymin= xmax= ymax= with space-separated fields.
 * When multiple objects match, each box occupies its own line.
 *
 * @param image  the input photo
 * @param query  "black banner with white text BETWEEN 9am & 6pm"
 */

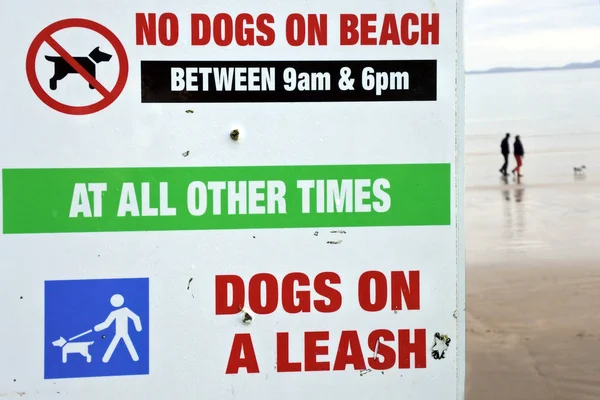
xmin=141 ymin=60 xmax=437 ymax=103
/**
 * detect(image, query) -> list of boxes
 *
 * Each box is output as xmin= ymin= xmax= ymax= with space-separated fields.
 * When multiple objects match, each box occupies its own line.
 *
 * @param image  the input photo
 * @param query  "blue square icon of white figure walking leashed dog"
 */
xmin=44 ymin=278 xmax=150 ymax=379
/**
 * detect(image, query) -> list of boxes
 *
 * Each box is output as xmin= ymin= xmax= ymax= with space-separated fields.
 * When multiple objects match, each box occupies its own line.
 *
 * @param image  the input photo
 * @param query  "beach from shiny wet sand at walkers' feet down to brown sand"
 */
xmin=466 ymin=139 xmax=600 ymax=400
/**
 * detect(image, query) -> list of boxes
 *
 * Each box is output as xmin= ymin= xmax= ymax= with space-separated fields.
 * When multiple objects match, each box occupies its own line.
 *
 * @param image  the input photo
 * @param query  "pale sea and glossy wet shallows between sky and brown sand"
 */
xmin=465 ymin=69 xmax=600 ymax=267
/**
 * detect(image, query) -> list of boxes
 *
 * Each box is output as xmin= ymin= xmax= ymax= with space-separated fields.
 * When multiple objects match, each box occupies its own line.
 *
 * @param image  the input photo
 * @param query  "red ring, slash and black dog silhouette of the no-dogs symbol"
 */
xmin=26 ymin=18 xmax=129 ymax=115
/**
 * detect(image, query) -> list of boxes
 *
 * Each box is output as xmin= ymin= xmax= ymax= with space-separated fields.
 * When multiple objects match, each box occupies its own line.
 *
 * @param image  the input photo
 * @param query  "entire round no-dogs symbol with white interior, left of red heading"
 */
xmin=26 ymin=18 xmax=129 ymax=115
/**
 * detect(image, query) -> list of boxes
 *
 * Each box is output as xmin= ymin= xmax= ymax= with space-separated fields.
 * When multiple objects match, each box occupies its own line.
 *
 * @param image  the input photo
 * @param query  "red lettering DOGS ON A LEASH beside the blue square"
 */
xmin=215 ymin=270 xmax=427 ymax=374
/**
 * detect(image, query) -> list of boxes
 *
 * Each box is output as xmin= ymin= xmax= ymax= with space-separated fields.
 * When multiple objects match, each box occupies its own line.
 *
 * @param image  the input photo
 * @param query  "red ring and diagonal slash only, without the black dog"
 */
xmin=26 ymin=18 xmax=129 ymax=115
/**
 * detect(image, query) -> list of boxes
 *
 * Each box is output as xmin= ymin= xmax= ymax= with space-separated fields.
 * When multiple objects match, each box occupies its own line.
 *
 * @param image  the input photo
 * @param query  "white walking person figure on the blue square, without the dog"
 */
xmin=94 ymin=294 xmax=142 ymax=363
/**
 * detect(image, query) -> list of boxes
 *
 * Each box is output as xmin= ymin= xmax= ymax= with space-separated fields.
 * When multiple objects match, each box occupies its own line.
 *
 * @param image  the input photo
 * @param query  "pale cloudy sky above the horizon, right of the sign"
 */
xmin=464 ymin=0 xmax=600 ymax=71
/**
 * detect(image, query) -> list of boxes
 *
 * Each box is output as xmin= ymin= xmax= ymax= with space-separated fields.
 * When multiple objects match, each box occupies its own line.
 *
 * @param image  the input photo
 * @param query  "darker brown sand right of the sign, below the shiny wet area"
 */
xmin=466 ymin=262 xmax=600 ymax=400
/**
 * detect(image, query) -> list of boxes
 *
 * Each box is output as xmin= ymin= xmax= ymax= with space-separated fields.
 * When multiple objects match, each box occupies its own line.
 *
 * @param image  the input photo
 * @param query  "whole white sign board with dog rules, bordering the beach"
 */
xmin=0 ymin=0 xmax=465 ymax=400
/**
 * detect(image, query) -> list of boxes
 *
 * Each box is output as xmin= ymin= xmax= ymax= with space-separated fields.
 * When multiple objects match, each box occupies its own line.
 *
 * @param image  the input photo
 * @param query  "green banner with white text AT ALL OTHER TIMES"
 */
xmin=2 ymin=164 xmax=452 ymax=234
